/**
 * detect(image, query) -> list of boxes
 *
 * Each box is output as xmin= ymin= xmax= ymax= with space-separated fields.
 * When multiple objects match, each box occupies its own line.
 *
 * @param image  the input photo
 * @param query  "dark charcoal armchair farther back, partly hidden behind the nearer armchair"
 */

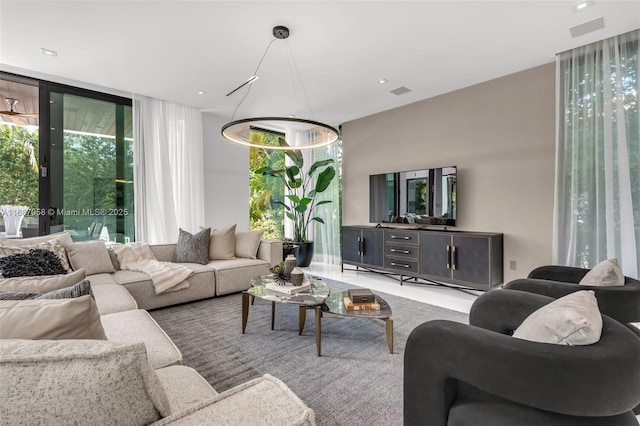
xmin=503 ymin=265 xmax=640 ymax=323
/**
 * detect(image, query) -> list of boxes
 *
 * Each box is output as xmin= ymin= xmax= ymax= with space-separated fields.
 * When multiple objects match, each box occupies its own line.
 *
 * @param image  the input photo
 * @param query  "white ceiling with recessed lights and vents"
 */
xmin=0 ymin=0 xmax=640 ymax=125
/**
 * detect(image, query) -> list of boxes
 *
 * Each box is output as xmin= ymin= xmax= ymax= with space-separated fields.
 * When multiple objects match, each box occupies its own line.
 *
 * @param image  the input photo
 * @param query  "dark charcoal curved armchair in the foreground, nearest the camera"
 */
xmin=404 ymin=290 xmax=640 ymax=426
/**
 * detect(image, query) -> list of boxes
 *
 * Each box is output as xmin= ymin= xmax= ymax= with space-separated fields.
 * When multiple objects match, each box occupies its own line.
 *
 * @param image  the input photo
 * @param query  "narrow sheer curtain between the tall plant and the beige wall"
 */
xmin=312 ymin=142 xmax=342 ymax=265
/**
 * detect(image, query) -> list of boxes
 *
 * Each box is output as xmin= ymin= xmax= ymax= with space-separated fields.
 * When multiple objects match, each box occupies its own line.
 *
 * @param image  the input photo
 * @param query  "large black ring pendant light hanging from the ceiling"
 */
xmin=221 ymin=26 xmax=339 ymax=150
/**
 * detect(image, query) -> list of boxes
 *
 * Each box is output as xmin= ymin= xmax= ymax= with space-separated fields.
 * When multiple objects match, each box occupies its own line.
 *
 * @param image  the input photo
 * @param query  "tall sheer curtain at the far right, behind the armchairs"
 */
xmin=553 ymin=31 xmax=640 ymax=277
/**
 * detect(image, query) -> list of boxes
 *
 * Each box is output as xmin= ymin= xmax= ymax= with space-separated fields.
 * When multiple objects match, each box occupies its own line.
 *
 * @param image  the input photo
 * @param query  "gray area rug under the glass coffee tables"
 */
xmin=150 ymin=279 xmax=468 ymax=426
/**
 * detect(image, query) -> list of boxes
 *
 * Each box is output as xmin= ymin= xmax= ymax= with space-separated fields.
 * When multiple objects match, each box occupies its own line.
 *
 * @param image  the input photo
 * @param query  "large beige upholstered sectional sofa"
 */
xmin=0 ymin=233 xmax=315 ymax=425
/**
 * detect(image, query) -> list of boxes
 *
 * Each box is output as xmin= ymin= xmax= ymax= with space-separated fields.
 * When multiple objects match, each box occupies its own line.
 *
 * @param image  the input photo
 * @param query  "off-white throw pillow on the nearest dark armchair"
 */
xmin=513 ymin=290 xmax=602 ymax=345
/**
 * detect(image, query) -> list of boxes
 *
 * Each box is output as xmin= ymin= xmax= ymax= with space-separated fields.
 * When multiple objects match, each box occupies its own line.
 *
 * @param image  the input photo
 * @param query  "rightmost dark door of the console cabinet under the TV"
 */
xmin=453 ymin=235 xmax=491 ymax=288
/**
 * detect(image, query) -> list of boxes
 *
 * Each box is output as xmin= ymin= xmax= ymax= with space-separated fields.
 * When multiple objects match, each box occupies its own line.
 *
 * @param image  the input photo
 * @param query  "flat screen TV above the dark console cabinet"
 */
xmin=369 ymin=166 xmax=458 ymax=226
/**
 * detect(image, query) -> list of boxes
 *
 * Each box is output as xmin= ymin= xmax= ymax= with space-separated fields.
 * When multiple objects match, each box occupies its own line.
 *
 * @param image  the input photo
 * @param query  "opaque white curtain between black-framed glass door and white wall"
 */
xmin=133 ymin=96 xmax=204 ymax=243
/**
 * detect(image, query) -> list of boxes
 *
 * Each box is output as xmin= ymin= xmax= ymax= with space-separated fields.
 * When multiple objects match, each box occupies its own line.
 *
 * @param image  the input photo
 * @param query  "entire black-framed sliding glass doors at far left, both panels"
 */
xmin=0 ymin=74 xmax=134 ymax=242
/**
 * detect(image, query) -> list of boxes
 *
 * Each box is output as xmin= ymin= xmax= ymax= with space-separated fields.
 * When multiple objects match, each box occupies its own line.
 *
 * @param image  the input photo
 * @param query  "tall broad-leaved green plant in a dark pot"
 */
xmin=256 ymin=137 xmax=336 ymax=266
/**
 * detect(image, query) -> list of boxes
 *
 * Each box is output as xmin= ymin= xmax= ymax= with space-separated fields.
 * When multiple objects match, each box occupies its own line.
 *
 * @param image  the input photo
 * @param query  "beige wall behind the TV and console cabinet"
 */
xmin=343 ymin=63 xmax=555 ymax=282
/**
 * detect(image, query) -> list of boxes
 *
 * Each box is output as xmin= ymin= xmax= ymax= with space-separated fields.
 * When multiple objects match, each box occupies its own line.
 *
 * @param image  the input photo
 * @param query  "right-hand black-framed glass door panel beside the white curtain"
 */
xmin=40 ymin=84 xmax=134 ymax=242
